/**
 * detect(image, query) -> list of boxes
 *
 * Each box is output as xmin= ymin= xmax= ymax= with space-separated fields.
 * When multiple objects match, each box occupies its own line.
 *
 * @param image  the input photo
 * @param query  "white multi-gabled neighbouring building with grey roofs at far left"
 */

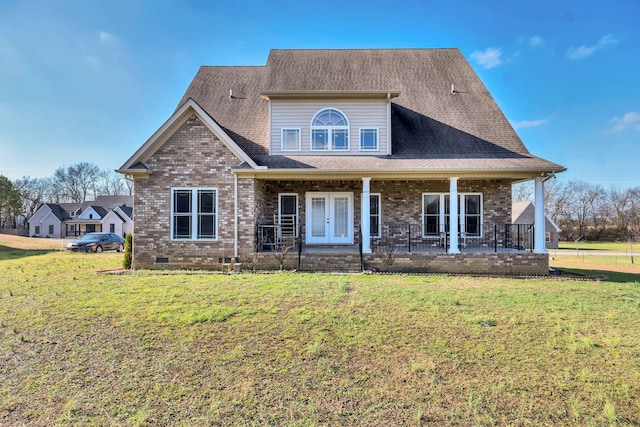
xmin=29 ymin=196 xmax=133 ymax=238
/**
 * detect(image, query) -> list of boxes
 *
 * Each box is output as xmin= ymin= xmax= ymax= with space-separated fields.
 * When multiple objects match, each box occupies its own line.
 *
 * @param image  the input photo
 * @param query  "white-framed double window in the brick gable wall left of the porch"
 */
xmin=171 ymin=188 xmax=218 ymax=240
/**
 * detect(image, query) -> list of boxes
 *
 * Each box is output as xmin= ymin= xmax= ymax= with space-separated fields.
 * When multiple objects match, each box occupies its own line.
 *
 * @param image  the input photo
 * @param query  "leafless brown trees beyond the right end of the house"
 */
xmin=513 ymin=179 xmax=640 ymax=242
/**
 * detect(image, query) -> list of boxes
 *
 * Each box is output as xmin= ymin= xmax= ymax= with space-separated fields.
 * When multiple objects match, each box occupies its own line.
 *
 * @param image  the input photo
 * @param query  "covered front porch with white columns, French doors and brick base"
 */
xmin=245 ymin=173 xmax=548 ymax=274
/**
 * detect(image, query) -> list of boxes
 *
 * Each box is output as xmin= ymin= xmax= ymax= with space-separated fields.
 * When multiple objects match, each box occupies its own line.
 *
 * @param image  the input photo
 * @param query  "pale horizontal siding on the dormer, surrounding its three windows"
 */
xmin=270 ymin=99 xmax=391 ymax=156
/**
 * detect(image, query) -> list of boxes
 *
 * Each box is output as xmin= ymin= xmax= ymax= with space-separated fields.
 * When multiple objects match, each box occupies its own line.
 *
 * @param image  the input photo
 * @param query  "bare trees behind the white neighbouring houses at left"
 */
xmin=0 ymin=162 xmax=133 ymax=228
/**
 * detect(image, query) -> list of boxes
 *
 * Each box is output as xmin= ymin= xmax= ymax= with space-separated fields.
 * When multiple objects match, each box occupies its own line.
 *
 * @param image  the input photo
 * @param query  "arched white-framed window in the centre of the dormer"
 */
xmin=311 ymin=108 xmax=349 ymax=151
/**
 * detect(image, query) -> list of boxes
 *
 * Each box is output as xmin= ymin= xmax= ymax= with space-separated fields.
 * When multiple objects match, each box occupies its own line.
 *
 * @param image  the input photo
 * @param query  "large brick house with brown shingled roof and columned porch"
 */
xmin=118 ymin=49 xmax=565 ymax=274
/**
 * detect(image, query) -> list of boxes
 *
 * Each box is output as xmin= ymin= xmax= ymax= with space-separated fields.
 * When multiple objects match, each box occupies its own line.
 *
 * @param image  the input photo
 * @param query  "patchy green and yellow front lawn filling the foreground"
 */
xmin=0 ymin=237 xmax=640 ymax=426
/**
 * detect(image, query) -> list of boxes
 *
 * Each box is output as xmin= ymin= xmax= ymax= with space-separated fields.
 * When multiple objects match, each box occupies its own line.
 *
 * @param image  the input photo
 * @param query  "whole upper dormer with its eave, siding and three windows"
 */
xmin=261 ymin=91 xmax=399 ymax=156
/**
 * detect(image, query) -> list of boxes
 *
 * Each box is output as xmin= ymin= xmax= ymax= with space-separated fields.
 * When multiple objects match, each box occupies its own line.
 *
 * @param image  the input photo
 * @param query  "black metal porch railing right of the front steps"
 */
xmin=371 ymin=224 xmax=534 ymax=253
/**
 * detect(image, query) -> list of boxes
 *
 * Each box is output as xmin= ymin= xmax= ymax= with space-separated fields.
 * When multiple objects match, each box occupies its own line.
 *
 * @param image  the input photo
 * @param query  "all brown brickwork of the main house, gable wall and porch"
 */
xmin=133 ymin=115 xmax=520 ymax=274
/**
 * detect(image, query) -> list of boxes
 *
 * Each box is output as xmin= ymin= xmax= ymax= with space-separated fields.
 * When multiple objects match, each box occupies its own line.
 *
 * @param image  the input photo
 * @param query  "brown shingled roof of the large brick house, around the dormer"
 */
xmin=122 ymin=49 xmax=565 ymax=177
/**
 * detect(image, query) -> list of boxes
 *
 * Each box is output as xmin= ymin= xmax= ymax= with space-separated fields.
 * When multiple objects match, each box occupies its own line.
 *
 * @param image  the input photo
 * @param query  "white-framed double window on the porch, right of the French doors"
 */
xmin=422 ymin=193 xmax=482 ymax=237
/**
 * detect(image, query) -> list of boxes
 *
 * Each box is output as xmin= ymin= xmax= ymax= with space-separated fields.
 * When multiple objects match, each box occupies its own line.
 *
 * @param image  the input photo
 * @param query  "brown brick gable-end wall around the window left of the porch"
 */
xmin=133 ymin=115 xmax=244 ymax=268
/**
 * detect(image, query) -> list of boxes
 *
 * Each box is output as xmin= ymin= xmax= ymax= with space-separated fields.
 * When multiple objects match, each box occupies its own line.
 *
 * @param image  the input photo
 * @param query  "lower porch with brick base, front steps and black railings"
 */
xmin=256 ymin=222 xmax=548 ymax=275
